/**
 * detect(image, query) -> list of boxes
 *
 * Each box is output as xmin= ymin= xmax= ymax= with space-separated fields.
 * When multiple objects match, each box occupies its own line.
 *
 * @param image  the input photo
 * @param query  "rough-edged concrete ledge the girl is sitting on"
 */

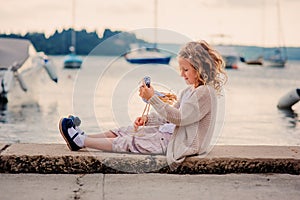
xmin=0 ymin=144 xmax=300 ymax=174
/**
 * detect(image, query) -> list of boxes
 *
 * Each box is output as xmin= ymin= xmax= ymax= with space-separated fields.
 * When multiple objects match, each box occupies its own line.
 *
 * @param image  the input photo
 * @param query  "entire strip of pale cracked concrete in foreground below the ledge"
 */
xmin=0 ymin=174 xmax=300 ymax=200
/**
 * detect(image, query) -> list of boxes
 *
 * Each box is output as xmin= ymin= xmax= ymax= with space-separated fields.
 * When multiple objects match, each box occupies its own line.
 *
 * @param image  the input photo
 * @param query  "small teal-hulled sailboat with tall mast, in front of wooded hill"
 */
xmin=64 ymin=0 xmax=82 ymax=69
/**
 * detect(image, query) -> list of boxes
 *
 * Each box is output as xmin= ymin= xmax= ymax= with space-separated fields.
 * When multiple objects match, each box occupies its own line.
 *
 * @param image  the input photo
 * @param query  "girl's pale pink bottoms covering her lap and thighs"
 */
xmin=111 ymin=126 xmax=171 ymax=154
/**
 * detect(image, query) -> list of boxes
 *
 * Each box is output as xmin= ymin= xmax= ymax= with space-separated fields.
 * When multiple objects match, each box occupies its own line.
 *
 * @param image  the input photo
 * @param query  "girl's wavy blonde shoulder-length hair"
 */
xmin=178 ymin=40 xmax=227 ymax=92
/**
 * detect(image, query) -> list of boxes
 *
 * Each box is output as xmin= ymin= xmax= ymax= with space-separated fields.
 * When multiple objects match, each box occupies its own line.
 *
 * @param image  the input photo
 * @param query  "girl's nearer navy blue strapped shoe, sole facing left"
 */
xmin=59 ymin=118 xmax=81 ymax=151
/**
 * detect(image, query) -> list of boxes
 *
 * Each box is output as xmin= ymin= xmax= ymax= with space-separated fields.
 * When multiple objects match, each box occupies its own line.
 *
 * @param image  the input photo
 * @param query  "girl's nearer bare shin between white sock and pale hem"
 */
xmin=84 ymin=137 xmax=114 ymax=151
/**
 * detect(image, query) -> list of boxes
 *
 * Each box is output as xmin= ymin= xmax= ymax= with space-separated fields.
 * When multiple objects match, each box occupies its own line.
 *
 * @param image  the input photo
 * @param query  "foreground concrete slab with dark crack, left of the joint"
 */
xmin=0 ymin=174 xmax=103 ymax=200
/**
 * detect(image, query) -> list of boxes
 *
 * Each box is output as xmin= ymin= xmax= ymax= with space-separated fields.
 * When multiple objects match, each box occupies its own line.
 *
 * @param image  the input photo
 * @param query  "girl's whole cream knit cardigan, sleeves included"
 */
xmin=147 ymin=86 xmax=217 ymax=169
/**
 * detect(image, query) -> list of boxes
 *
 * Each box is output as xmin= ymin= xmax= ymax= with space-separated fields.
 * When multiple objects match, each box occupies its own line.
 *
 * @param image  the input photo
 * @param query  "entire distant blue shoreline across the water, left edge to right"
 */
xmin=0 ymin=29 xmax=300 ymax=60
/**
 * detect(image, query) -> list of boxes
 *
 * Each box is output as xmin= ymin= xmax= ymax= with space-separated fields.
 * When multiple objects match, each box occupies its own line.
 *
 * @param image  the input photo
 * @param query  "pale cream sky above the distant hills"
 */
xmin=0 ymin=0 xmax=300 ymax=46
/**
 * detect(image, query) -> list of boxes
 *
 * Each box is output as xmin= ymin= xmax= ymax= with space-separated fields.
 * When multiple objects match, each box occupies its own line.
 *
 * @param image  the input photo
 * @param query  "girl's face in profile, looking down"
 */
xmin=178 ymin=57 xmax=199 ymax=87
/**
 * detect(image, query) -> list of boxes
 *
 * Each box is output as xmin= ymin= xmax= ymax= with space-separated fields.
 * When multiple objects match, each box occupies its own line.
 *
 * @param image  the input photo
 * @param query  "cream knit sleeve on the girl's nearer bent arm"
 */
xmin=149 ymin=86 xmax=211 ymax=126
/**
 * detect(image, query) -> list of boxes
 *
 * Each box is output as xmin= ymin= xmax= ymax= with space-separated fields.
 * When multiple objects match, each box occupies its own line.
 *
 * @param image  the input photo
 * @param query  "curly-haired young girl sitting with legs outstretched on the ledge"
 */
xmin=59 ymin=41 xmax=227 ymax=167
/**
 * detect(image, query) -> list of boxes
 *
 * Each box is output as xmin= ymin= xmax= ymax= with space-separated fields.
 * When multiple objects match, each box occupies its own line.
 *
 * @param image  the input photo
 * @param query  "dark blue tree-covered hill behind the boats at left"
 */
xmin=0 ymin=28 xmax=146 ymax=55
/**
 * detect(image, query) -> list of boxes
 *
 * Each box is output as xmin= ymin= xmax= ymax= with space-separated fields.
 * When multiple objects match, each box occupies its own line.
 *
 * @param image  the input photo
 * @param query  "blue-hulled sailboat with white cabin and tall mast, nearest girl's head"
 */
xmin=124 ymin=0 xmax=171 ymax=64
